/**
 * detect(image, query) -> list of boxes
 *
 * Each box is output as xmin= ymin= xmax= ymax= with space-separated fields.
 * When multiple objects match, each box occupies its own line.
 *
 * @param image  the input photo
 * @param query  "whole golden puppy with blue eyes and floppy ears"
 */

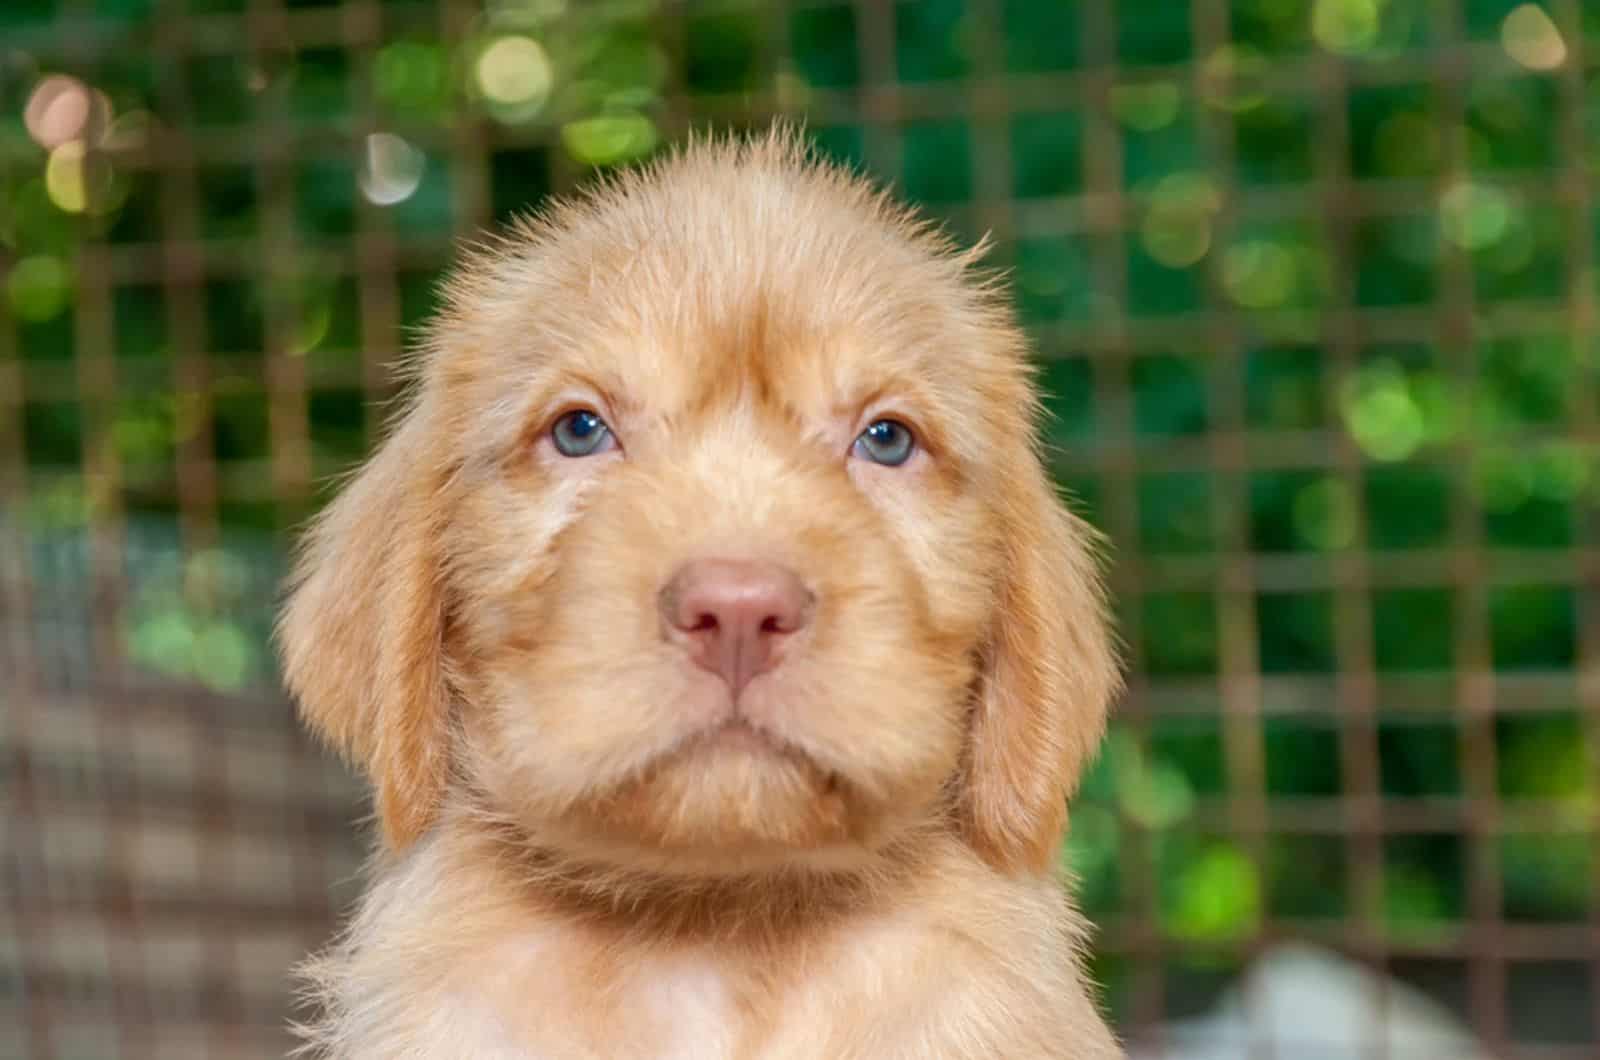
xmin=280 ymin=131 xmax=1118 ymax=1060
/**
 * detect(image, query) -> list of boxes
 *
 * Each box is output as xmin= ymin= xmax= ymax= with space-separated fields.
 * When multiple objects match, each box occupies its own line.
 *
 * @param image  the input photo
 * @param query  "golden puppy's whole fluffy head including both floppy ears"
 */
xmin=282 ymin=135 xmax=1115 ymax=874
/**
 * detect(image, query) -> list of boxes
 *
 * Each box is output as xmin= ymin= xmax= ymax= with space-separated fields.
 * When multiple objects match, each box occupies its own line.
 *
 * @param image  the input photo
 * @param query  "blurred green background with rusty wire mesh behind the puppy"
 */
xmin=0 ymin=0 xmax=1600 ymax=1060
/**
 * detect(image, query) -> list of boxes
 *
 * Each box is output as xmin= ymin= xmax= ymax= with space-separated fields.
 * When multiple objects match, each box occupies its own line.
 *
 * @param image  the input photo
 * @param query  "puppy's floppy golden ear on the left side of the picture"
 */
xmin=278 ymin=397 xmax=450 ymax=849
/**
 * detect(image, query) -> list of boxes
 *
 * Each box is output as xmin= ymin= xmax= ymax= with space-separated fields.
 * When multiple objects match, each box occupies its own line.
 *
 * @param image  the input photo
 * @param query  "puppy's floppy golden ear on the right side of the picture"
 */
xmin=962 ymin=455 xmax=1120 ymax=873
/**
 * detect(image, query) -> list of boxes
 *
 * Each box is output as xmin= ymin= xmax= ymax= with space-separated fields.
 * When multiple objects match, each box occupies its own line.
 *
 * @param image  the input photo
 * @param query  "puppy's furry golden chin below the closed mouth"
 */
xmin=541 ymin=722 xmax=915 ymax=877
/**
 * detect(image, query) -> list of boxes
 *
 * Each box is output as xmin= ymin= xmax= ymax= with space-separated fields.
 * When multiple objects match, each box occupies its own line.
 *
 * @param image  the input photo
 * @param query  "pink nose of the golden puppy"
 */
xmin=661 ymin=559 xmax=811 ymax=697
